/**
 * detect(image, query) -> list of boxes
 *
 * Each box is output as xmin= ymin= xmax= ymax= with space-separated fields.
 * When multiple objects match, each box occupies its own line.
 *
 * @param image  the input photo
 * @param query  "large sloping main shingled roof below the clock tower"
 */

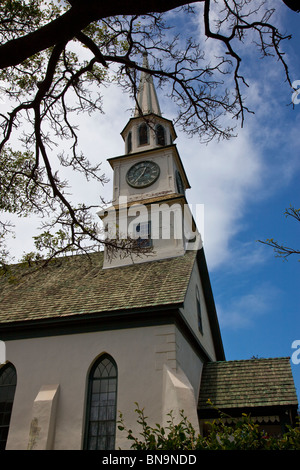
xmin=0 ymin=251 xmax=196 ymax=325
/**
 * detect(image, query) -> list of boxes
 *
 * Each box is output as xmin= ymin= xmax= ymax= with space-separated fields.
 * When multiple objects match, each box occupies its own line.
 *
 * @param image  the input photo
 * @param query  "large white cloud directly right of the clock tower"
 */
xmin=178 ymin=126 xmax=263 ymax=269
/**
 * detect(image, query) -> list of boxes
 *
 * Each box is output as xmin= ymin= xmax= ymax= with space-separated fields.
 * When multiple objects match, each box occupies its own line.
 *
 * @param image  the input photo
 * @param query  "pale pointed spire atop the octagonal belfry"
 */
xmin=134 ymin=52 xmax=161 ymax=117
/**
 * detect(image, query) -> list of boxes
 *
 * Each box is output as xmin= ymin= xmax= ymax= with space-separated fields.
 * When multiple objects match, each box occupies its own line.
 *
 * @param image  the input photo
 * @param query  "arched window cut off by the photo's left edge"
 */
xmin=0 ymin=363 xmax=17 ymax=450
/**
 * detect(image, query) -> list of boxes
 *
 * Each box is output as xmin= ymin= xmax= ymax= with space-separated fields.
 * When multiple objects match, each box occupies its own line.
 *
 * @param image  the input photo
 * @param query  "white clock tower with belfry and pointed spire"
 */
xmin=99 ymin=54 xmax=200 ymax=268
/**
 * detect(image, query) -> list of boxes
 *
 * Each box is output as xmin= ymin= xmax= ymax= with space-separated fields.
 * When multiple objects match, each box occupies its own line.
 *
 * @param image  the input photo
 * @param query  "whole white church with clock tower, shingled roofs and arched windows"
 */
xmin=0 ymin=53 xmax=298 ymax=450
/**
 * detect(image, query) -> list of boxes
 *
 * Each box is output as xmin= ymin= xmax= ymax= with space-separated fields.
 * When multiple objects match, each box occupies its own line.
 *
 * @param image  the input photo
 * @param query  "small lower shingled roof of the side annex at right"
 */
xmin=199 ymin=357 xmax=297 ymax=410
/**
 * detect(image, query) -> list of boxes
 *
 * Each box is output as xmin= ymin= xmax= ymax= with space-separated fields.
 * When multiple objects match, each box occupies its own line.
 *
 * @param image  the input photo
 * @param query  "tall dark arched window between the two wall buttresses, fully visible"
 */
xmin=84 ymin=354 xmax=118 ymax=450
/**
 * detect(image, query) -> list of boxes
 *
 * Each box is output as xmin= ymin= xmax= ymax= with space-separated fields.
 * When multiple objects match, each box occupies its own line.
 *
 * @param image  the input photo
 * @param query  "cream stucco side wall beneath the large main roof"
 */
xmin=6 ymin=325 xmax=201 ymax=450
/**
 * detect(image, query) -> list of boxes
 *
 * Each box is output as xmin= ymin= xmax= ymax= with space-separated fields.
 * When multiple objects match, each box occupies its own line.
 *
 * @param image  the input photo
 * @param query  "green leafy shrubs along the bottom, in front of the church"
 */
xmin=118 ymin=404 xmax=300 ymax=450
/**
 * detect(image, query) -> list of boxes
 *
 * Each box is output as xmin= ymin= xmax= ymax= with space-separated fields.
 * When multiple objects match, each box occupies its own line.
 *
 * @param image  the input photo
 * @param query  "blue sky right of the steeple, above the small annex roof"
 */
xmin=185 ymin=5 xmax=300 ymax=398
